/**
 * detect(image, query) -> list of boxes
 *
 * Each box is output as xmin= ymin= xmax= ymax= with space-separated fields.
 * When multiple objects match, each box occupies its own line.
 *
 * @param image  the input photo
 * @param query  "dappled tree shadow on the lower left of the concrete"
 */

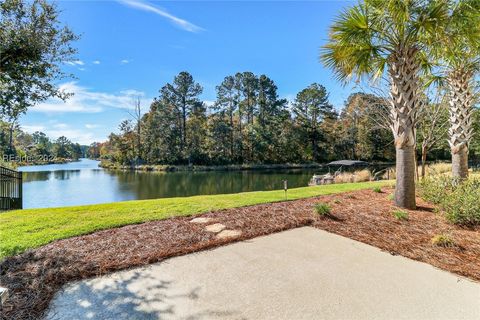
xmin=46 ymin=272 xmax=242 ymax=320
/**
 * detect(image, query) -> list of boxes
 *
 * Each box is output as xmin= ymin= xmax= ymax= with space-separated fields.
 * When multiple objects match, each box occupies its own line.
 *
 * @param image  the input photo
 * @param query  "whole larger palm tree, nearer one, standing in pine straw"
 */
xmin=321 ymin=0 xmax=448 ymax=209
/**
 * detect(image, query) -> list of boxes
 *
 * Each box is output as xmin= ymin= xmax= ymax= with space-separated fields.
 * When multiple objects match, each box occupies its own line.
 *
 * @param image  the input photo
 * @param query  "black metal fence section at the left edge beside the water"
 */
xmin=0 ymin=167 xmax=22 ymax=211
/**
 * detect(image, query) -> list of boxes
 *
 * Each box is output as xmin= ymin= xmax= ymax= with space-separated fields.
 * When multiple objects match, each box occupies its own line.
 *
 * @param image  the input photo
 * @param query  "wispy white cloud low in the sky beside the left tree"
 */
xmin=31 ymin=82 xmax=151 ymax=113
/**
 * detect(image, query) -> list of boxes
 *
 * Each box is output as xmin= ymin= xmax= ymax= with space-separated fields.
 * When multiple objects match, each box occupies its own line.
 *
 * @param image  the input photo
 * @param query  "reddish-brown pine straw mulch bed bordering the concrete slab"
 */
xmin=0 ymin=188 xmax=480 ymax=319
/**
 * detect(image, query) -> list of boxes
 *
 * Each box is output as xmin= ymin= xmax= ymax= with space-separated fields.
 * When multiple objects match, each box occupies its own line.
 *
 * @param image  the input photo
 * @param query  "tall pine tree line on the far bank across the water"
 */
xmin=89 ymin=72 xmax=478 ymax=165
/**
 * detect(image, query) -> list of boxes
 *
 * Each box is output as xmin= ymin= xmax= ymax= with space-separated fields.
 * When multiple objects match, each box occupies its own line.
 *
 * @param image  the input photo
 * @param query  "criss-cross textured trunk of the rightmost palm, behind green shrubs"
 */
xmin=447 ymin=69 xmax=474 ymax=180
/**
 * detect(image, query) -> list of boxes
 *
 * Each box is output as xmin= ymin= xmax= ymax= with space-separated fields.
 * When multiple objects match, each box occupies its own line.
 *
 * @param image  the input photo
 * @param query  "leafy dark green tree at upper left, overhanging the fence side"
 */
xmin=0 ymin=0 xmax=77 ymax=152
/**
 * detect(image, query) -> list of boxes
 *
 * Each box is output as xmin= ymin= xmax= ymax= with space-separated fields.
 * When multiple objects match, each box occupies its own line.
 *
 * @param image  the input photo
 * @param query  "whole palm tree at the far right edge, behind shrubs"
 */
xmin=436 ymin=0 xmax=480 ymax=180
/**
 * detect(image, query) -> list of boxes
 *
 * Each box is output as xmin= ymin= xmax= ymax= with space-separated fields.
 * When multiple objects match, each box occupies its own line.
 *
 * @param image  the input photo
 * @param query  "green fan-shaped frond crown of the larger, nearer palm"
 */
xmin=320 ymin=0 xmax=454 ymax=85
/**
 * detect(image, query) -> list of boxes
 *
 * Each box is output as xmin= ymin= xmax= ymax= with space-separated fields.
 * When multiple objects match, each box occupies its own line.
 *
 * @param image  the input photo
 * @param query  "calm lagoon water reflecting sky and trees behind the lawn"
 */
xmin=19 ymin=159 xmax=326 ymax=208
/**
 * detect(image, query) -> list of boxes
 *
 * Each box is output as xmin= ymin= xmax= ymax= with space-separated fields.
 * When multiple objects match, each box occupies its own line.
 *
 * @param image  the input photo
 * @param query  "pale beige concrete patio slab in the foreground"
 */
xmin=47 ymin=227 xmax=480 ymax=320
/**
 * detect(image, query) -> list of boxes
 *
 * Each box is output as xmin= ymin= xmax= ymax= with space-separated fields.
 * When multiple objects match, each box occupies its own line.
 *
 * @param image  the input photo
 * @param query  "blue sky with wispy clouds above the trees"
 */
xmin=20 ymin=0 xmax=352 ymax=144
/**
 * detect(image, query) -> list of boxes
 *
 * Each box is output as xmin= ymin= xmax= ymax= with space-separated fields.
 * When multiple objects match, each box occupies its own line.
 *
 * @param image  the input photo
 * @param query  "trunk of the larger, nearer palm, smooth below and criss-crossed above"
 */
xmin=389 ymin=48 xmax=419 ymax=209
